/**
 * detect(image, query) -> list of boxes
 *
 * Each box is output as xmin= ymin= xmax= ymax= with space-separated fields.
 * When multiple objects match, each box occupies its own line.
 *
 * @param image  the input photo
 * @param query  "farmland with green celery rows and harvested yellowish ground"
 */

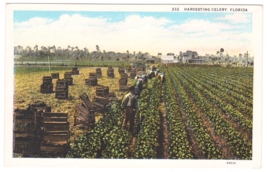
xmin=14 ymin=65 xmax=253 ymax=159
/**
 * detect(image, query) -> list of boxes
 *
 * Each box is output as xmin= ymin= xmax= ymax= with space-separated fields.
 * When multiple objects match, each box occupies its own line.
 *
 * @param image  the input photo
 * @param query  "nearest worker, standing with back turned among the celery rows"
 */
xmin=121 ymin=86 xmax=137 ymax=132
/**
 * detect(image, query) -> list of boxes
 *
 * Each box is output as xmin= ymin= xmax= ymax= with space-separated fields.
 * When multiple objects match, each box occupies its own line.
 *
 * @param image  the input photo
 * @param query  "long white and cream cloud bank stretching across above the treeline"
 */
xmin=14 ymin=14 xmax=252 ymax=55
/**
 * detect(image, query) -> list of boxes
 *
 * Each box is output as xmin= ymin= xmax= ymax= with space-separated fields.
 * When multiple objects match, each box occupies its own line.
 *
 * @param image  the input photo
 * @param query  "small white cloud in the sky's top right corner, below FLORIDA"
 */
xmin=215 ymin=13 xmax=251 ymax=24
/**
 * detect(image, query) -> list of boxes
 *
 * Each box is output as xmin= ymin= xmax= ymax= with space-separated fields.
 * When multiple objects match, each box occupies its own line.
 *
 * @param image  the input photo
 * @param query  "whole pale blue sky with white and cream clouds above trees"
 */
xmin=13 ymin=11 xmax=254 ymax=56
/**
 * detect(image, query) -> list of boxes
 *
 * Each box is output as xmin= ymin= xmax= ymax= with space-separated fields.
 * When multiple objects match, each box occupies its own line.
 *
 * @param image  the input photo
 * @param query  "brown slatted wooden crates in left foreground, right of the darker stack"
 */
xmin=40 ymin=112 xmax=70 ymax=154
